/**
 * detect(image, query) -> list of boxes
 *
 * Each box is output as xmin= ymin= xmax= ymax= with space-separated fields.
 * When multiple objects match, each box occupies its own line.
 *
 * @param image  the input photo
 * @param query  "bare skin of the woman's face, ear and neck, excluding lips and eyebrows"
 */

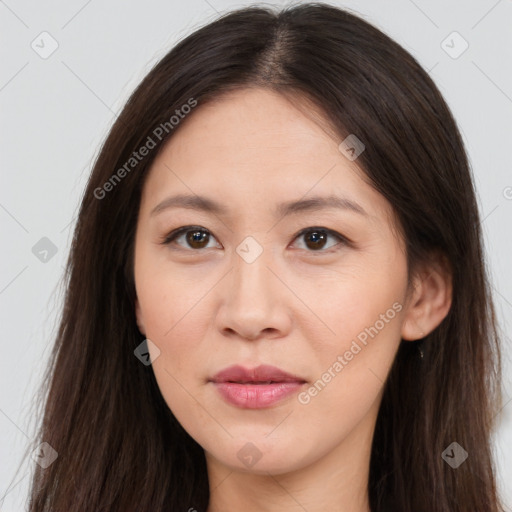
xmin=134 ymin=89 xmax=451 ymax=512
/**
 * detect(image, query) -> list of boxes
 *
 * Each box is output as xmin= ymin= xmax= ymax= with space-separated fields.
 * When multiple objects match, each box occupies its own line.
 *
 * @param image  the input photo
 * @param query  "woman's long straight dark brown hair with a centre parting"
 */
xmin=24 ymin=3 xmax=502 ymax=512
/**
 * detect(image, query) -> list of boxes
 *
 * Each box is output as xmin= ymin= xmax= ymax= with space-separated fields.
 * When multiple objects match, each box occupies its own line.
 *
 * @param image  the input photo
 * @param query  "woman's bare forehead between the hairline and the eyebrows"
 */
xmin=143 ymin=89 xmax=391 ymax=229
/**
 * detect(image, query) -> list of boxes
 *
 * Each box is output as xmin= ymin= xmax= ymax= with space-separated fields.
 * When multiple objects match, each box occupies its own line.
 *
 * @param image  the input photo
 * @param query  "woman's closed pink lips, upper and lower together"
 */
xmin=211 ymin=365 xmax=306 ymax=409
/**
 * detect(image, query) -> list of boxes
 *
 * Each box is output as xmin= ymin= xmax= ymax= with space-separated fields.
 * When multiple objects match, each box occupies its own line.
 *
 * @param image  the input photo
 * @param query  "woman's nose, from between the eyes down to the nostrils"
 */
xmin=216 ymin=246 xmax=293 ymax=340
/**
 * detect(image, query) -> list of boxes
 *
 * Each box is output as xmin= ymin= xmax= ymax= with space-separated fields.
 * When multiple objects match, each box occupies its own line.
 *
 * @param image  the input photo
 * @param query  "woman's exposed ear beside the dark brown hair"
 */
xmin=402 ymin=253 xmax=452 ymax=341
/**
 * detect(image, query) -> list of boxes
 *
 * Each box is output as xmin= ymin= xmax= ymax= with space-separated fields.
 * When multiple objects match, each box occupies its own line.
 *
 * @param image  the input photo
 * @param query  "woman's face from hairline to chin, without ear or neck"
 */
xmin=134 ymin=89 xmax=407 ymax=474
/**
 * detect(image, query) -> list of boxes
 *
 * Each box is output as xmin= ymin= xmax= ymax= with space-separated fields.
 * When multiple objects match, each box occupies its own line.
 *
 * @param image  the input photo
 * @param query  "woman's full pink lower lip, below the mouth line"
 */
xmin=214 ymin=381 xmax=303 ymax=409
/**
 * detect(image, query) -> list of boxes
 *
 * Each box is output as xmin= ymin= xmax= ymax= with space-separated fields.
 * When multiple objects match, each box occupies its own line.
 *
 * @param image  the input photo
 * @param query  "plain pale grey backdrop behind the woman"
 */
xmin=0 ymin=0 xmax=512 ymax=512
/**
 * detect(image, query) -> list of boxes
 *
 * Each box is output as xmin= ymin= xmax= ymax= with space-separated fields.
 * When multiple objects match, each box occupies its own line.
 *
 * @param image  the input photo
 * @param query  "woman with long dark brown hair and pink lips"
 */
xmin=25 ymin=4 xmax=503 ymax=512
